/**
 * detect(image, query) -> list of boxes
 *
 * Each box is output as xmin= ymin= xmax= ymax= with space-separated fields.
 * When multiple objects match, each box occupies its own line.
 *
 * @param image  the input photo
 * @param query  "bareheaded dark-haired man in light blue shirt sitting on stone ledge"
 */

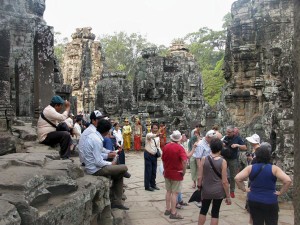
xmin=79 ymin=119 xmax=129 ymax=210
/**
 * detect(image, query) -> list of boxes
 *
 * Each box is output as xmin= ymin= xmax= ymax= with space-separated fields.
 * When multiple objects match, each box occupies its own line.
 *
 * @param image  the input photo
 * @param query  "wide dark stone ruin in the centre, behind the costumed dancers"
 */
xmin=133 ymin=42 xmax=204 ymax=131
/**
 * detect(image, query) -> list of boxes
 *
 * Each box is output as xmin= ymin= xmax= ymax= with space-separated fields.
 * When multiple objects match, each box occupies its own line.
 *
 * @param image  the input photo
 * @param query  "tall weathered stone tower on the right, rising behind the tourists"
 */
xmin=223 ymin=0 xmax=294 ymax=172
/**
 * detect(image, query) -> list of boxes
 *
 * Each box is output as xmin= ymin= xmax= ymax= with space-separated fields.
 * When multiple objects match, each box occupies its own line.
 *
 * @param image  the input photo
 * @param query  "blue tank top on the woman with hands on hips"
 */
xmin=248 ymin=163 xmax=278 ymax=204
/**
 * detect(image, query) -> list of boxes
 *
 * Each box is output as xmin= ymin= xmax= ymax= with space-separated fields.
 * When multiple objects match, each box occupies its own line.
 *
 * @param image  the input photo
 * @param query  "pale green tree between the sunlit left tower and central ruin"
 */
xmin=99 ymin=32 xmax=151 ymax=79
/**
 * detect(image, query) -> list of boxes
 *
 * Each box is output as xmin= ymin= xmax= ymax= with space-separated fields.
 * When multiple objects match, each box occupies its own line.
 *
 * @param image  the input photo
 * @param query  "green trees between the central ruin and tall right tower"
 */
xmin=184 ymin=13 xmax=232 ymax=106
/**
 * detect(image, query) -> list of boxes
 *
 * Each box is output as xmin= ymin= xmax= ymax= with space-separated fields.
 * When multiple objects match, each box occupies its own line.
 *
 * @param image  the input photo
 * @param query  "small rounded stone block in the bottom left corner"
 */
xmin=0 ymin=200 xmax=21 ymax=225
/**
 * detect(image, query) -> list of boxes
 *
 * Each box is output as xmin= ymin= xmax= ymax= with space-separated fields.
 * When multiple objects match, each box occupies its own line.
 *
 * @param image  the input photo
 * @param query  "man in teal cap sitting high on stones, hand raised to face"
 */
xmin=37 ymin=95 xmax=72 ymax=159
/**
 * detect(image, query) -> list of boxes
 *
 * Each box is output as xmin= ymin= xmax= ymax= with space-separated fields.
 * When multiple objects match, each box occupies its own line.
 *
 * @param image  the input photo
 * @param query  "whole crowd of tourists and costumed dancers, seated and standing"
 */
xmin=38 ymin=96 xmax=291 ymax=225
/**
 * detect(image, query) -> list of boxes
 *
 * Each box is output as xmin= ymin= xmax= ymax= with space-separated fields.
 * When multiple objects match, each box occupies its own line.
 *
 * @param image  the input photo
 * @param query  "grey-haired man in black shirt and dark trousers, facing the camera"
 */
xmin=222 ymin=126 xmax=247 ymax=198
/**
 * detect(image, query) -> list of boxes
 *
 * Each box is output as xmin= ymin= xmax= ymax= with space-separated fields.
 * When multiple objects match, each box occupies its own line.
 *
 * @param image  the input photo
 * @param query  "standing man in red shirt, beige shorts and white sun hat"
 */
xmin=162 ymin=130 xmax=187 ymax=219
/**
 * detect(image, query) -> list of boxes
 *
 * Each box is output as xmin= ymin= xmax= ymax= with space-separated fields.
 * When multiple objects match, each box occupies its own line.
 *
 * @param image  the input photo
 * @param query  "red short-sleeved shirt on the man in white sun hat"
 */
xmin=162 ymin=142 xmax=187 ymax=181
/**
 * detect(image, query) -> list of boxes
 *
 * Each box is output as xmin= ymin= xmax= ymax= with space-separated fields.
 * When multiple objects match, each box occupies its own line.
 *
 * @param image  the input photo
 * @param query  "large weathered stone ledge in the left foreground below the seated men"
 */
xmin=0 ymin=149 xmax=112 ymax=225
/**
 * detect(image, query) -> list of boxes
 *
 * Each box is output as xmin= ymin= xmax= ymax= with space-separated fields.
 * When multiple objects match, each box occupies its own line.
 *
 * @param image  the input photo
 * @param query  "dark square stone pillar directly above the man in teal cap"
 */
xmin=33 ymin=25 xmax=54 ymax=125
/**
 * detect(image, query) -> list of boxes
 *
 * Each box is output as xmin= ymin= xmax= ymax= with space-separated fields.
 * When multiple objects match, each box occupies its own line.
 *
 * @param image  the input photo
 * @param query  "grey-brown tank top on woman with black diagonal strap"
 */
xmin=202 ymin=155 xmax=226 ymax=199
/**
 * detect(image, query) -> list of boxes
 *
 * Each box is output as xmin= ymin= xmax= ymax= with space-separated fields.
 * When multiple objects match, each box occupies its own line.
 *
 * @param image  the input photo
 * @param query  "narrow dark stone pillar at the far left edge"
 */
xmin=0 ymin=30 xmax=12 ymax=131
